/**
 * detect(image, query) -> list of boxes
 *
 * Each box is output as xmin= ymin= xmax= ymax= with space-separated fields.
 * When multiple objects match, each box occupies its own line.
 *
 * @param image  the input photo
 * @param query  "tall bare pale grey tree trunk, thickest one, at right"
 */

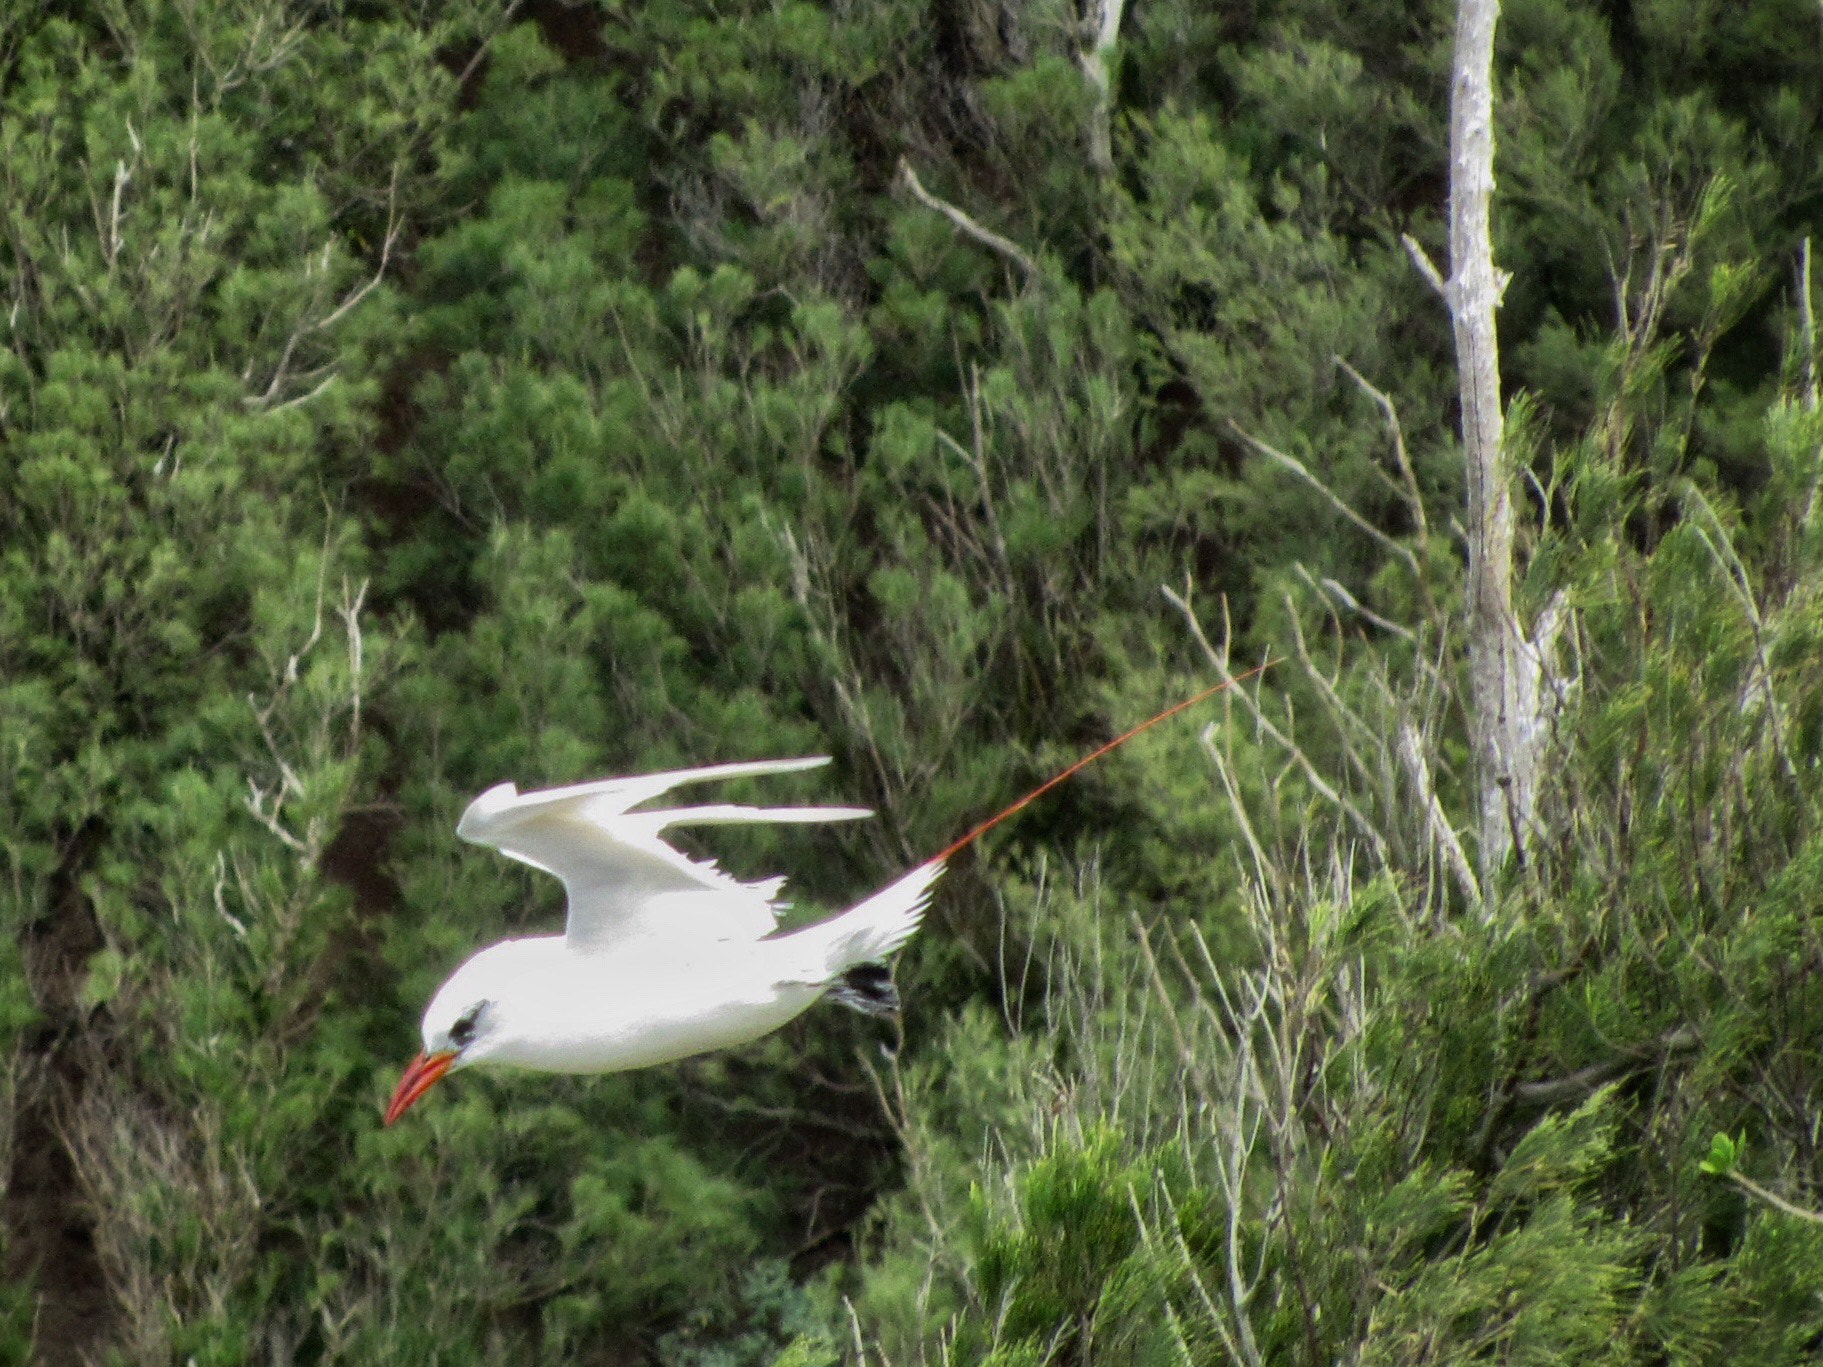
xmin=1444 ymin=0 xmax=1559 ymax=888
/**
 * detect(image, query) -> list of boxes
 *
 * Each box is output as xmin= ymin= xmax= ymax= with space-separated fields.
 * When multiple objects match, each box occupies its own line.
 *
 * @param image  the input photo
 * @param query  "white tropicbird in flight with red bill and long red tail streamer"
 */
xmin=385 ymin=665 xmax=1265 ymax=1125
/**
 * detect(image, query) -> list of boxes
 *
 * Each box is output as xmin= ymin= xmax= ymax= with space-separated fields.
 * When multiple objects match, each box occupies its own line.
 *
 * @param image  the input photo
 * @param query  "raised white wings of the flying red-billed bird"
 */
xmin=456 ymin=756 xmax=873 ymax=951
